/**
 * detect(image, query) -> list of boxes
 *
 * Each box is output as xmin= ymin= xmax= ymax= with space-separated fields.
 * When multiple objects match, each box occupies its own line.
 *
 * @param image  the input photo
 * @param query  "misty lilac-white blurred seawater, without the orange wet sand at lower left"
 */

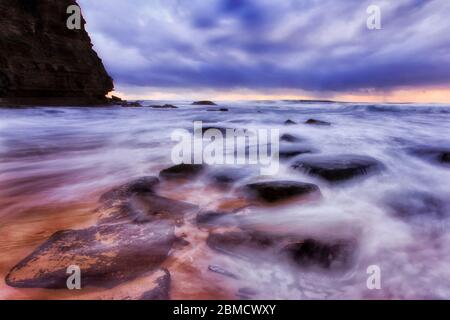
xmin=0 ymin=101 xmax=450 ymax=299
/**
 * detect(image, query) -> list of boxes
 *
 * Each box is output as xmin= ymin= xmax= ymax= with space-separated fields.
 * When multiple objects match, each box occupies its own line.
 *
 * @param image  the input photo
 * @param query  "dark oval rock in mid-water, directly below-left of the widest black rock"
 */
xmin=243 ymin=181 xmax=320 ymax=203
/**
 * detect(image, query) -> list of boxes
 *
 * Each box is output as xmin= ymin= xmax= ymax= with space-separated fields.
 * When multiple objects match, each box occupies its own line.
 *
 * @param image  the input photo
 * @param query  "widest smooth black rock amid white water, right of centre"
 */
xmin=292 ymin=155 xmax=383 ymax=183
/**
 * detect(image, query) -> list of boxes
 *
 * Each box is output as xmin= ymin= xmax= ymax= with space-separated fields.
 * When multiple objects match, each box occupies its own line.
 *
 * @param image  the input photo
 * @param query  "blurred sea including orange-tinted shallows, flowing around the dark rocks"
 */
xmin=0 ymin=101 xmax=450 ymax=299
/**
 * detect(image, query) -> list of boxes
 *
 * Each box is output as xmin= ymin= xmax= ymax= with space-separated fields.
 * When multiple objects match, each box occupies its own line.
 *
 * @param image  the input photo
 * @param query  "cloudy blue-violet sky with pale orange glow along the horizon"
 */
xmin=78 ymin=0 xmax=450 ymax=102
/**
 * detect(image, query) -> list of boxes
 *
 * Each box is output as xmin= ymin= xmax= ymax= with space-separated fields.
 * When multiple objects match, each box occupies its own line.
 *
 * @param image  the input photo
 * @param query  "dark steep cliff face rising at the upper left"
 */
xmin=0 ymin=0 xmax=113 ymax=105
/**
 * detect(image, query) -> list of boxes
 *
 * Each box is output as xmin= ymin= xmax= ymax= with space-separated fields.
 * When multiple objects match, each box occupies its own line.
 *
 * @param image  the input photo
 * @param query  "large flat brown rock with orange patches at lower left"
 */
xmin=5 ymin=221 xmax=176 ymax=289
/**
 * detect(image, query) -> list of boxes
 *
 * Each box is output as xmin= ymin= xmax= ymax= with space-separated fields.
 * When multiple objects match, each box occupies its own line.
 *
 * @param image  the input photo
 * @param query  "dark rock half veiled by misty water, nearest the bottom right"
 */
xmin=282 ymin=239 xmax=356 ymax=270
